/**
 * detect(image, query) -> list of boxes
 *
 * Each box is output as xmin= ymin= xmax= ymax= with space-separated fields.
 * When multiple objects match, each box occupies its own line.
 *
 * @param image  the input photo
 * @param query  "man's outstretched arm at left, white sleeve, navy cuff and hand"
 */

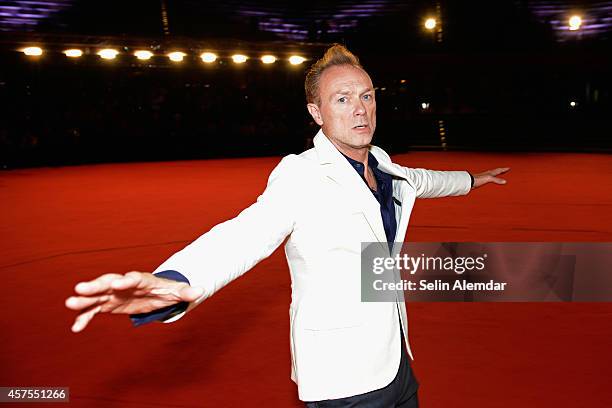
xmin=66 ymin=155 xmax=307 ymax=332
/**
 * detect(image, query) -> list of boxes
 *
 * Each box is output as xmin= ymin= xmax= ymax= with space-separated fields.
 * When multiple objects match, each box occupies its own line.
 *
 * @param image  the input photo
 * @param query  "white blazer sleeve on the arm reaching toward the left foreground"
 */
xmin=154 ymin=155 xmax=303 ymax=323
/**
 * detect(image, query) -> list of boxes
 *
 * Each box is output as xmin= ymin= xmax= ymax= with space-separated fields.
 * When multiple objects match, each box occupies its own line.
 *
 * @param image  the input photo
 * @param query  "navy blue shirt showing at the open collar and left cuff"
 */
xmin=130 ymin=153 xmax=397 ymax=326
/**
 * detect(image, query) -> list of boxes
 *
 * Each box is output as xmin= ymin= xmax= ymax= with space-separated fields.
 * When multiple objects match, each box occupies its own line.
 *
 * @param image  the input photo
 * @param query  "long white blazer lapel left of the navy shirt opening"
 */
xmin=313 ymin=130 xmax=387 ymax=245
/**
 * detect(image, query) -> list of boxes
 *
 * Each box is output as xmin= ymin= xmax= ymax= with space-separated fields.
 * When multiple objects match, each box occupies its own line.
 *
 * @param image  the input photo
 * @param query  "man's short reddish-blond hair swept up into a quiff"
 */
xmin=304 ymin=44 xmax=365 ymax=105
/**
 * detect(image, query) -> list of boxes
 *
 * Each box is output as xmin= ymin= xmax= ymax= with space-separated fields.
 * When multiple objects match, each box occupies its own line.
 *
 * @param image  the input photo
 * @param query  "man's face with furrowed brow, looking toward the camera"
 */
xmin=308 ymin=65 xmax=376 ymax=154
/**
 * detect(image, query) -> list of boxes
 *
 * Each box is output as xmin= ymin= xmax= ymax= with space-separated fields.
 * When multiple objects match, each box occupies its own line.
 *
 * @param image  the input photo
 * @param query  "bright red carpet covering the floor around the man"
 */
xmin=0 ymin=153 xmax=612 ymax=408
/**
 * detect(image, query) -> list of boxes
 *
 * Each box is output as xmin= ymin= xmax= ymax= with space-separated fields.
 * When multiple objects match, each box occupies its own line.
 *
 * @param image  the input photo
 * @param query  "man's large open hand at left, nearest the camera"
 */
xmin=66 ymin=272 xmax=203 ymax=333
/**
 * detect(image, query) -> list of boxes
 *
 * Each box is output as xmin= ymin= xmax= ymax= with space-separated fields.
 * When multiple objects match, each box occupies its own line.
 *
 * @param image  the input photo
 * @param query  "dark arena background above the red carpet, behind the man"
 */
xmin=0 ymin=0 xmax=612 ymax=168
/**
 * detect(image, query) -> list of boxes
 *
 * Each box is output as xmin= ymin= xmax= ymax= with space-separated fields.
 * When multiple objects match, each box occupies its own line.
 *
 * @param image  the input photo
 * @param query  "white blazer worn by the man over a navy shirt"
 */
xmin=156 ymin=131 xmax=471 ymax=401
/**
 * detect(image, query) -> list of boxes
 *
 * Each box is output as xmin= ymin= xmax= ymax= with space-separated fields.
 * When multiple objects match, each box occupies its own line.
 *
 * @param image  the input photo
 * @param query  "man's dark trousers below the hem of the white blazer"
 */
xmin=306 ymin=328 xmax=419 ymax=408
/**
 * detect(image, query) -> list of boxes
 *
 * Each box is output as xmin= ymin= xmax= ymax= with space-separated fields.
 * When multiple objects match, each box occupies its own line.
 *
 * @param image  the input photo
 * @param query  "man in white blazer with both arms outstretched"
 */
xmin=66 ymin=45 xmax=508 ymax=408
